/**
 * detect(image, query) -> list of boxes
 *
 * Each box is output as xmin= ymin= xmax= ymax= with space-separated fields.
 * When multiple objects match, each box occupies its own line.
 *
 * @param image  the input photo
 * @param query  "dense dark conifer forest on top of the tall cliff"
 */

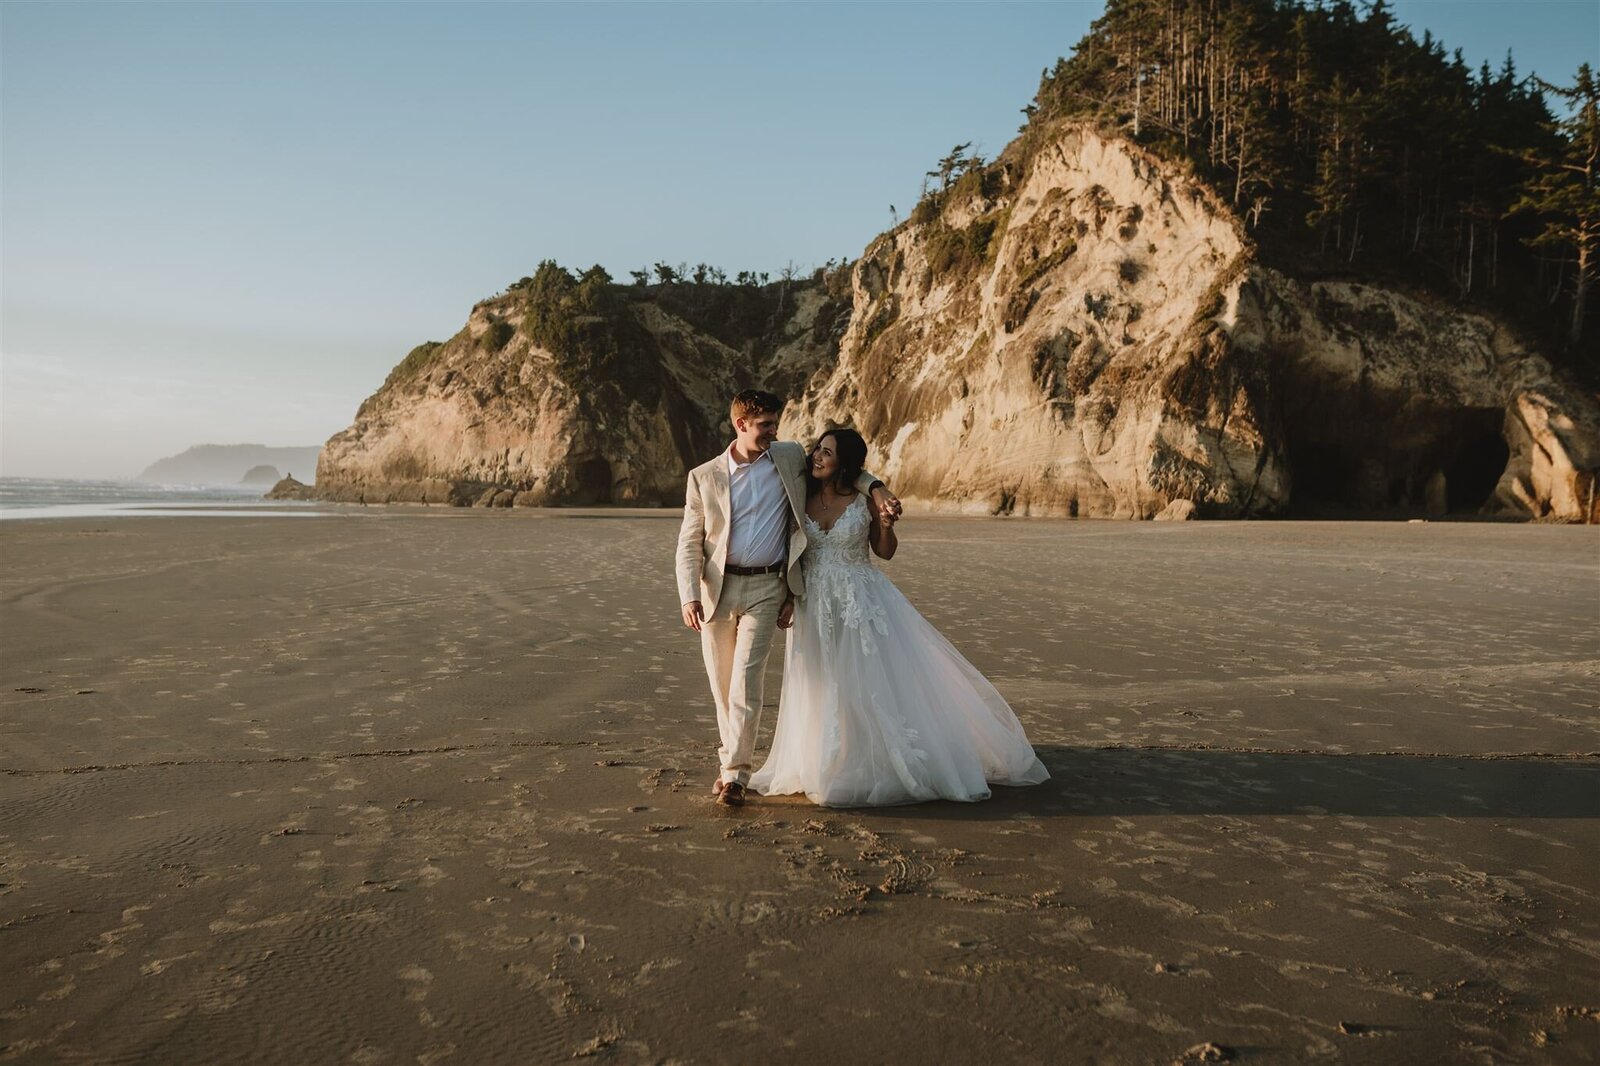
xmin=1018 ymin=0 xmax=1600 ymax=372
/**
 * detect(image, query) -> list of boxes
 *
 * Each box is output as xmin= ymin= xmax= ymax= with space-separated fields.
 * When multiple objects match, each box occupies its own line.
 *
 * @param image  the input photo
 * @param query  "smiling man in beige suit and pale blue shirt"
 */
xmin=677 ymin=389 xmax=901 ymax=807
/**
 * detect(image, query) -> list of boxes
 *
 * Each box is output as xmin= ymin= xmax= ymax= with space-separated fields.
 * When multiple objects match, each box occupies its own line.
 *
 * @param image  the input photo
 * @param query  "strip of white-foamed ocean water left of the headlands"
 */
xmin=0 ymin=477 xmax=325 ymax=520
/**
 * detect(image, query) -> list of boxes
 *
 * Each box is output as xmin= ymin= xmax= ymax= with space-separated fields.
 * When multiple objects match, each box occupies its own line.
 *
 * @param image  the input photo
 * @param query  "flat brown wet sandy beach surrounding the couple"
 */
xmin=0 ymin=507 xmax=1600 ymax=1064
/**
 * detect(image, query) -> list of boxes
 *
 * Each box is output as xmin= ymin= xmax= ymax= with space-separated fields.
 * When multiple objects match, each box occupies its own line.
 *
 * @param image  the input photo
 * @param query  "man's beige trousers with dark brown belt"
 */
xmin=701 ymin=573 xmax=784 ymax=784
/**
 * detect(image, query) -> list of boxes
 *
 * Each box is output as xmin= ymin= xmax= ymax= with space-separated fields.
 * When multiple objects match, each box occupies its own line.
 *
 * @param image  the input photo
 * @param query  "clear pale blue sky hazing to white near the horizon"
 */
xmin=0 ymin=0 xmax=1600 ymax=477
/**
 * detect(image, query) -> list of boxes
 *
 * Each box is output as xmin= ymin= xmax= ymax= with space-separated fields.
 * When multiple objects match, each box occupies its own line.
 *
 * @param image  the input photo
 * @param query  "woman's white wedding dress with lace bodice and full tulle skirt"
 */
xmin=750 ymin=495 xmax=1050 ymax=807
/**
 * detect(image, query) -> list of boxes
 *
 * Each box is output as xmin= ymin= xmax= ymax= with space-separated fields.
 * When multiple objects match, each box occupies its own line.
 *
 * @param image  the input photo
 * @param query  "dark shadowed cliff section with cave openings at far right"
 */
xmin=1229 ymin=267 xmax=1600 ymax=520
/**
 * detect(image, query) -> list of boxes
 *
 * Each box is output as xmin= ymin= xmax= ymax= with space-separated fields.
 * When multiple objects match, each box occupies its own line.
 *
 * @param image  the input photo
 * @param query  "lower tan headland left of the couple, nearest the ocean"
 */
xmin=308 ymin=278 xmax=840 ymax=507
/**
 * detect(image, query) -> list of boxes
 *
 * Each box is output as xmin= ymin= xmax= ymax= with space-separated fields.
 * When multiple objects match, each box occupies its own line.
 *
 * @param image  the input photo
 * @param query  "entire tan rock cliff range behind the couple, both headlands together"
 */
xmin=317 ymin=125 xmax=1600 ymax=520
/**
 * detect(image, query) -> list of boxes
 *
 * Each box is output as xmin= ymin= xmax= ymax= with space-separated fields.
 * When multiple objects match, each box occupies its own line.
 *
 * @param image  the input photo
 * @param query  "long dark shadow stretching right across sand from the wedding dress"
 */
xmin=851 ymin=744 xmax=1600 ymax=820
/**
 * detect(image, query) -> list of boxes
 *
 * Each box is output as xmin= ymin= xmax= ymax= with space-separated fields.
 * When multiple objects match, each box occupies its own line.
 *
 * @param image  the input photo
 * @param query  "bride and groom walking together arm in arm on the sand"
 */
xmin=677 ymin=389 xmax=1050 ymax=807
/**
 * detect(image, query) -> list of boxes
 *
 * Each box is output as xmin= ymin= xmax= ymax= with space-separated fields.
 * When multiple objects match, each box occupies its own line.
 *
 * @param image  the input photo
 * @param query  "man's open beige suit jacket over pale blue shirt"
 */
xmin=677 ymin=440 xmax=878 ymax=619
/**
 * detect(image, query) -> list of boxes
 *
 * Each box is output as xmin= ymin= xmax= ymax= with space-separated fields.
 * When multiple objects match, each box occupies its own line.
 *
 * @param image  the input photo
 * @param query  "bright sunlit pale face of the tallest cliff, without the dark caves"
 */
xmin=784 ymin=130 xmax=1290 ymax=517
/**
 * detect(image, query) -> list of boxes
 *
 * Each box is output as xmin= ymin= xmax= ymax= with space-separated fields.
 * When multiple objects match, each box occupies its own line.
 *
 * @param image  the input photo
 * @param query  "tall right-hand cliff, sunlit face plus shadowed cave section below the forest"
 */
xmin=784 ymin=128 xmax=1600 ymax=520
